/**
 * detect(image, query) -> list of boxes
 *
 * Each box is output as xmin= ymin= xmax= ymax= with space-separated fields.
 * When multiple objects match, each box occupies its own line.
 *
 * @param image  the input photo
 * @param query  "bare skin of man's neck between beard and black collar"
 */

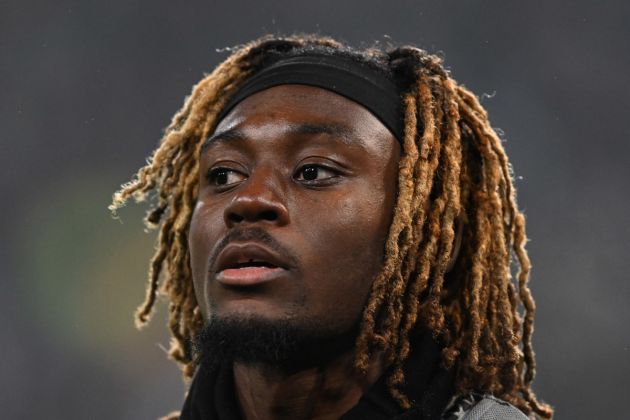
xmin=234 ymin=351 xmax=384 ymax=420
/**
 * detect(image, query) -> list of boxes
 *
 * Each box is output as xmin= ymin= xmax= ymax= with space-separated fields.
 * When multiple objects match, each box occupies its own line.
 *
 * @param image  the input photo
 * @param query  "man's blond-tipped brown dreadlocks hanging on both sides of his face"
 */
xmin=110 ymin=36 xmax=553 ymax=418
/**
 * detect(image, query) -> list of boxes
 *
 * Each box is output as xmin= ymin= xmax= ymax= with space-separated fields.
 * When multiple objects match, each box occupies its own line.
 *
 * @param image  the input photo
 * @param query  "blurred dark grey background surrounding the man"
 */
xmin=0 ymin=0 xmax=630 ymax=419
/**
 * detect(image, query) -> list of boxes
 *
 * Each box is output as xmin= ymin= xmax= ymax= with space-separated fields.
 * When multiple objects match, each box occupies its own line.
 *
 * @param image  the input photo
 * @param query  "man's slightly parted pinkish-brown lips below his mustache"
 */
xmin=214 ymin=242 xmax=289 ymax=287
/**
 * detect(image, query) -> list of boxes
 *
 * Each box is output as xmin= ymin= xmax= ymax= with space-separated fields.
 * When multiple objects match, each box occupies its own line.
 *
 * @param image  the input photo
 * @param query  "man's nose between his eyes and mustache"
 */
xmin=223 ymin=171 xmax=289 ymax=227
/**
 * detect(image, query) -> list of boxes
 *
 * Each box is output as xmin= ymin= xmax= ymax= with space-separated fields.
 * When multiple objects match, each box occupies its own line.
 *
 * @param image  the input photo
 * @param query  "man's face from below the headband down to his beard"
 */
xmin=189 ymin=85 xmax=400 ymax=344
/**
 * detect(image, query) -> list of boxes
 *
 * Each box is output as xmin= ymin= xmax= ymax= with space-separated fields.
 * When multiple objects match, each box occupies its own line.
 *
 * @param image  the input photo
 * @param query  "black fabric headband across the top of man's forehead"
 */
xmin=219 ymin=55 xmax=404 ymax=143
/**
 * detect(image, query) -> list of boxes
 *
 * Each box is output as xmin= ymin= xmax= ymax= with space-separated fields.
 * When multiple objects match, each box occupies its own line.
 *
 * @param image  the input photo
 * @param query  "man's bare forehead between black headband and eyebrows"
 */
xmin=208 ymin=85 xmax=398 ymax=152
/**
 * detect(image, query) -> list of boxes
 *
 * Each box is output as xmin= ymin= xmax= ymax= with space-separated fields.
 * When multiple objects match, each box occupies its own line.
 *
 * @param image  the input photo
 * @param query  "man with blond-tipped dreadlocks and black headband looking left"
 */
xmin=112 ymin=37 xmax=552 ymax=419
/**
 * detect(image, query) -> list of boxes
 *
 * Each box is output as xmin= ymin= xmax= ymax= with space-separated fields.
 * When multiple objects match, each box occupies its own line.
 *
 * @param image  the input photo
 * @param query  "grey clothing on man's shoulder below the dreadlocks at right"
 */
xmin=443 ymin=393 xmax=528 ymax=420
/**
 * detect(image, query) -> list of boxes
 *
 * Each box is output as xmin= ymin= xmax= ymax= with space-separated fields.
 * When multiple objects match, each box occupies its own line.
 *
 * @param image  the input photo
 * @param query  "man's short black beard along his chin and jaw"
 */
xmin=193 ymin=317 xmax=359 ymax=373
